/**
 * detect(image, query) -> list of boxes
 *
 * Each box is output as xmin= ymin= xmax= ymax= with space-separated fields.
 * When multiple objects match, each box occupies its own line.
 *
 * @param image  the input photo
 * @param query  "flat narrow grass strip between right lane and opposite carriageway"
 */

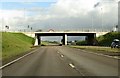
xmin=70 ymin=46 xmax=120 ymax=52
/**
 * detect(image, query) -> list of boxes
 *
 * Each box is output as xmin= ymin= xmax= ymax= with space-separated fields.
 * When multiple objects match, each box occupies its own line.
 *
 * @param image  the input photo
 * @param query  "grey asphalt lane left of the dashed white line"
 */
xmin=2 ymin=46 xmax=81 ymax=76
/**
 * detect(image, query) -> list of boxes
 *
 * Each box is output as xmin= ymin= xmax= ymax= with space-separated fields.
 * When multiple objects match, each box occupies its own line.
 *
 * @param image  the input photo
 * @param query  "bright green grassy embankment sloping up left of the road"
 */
xmin=2 ymin=32 xmax=34 ymax=63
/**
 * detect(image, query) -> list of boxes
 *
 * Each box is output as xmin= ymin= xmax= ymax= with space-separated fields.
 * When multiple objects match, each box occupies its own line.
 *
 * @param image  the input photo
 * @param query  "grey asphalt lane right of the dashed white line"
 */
xmin=56 ymin=47 xmax=118 ymax=76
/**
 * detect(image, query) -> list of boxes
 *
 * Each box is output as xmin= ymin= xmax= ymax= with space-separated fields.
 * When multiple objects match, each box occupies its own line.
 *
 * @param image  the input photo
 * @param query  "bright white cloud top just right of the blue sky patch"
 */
xmin=52 ymin=0 xmax=95 ymax=16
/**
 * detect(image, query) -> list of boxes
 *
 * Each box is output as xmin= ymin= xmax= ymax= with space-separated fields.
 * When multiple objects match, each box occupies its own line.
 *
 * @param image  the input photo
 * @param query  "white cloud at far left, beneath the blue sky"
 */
xmin=0 ymin=10 xmax=24 ymax=30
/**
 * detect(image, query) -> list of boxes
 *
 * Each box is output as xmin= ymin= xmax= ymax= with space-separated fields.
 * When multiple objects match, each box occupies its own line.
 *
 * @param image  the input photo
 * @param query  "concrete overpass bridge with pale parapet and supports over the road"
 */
xmin=29 ymin=31 xmax=108 ymax=46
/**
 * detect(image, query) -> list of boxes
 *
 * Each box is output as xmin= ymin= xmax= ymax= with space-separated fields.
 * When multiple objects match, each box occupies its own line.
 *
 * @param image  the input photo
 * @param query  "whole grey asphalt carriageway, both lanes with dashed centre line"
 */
xmin=2 ymin=46 xmax=118 ymax=76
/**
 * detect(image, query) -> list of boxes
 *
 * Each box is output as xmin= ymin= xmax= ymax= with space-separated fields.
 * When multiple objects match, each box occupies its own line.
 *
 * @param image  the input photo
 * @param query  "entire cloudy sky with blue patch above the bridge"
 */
xmin=0 ymin=0 xmax=118 ymax=31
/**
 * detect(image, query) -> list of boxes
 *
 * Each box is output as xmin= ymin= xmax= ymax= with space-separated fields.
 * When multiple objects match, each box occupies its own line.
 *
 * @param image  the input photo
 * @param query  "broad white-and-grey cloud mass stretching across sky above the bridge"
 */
xmin=0 ymin=0 xmax=118 ymax=30
